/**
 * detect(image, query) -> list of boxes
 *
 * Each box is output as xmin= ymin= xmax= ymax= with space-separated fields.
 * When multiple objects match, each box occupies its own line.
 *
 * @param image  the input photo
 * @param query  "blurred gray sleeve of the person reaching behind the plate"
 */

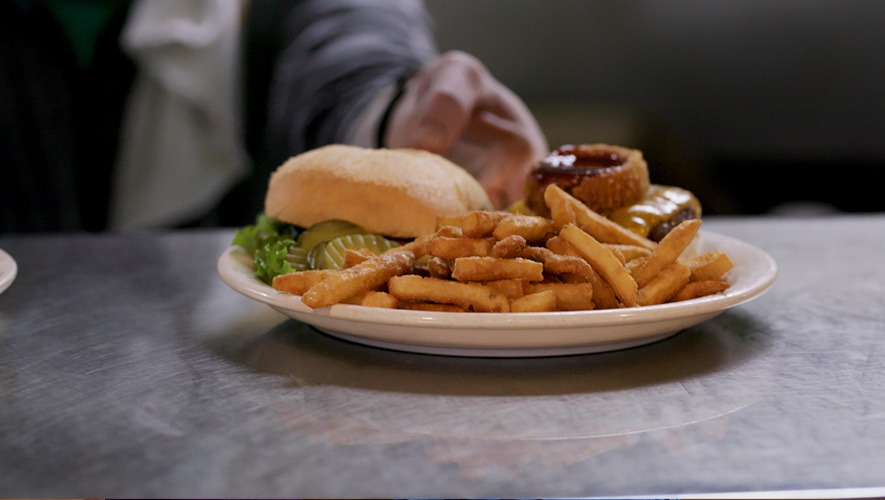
xmin=266 ymin=0 xmax=438 ymax=154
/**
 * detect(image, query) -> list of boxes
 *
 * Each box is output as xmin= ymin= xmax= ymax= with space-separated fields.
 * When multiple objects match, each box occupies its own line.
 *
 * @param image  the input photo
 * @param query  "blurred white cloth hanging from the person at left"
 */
xmin=111 ymin=0 xmax=249 ymax=230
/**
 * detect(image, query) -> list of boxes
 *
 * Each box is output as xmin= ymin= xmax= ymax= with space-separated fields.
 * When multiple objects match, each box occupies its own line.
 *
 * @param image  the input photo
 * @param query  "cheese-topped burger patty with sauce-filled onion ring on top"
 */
xmin=524 ymin=144 xmax=701 ymax=241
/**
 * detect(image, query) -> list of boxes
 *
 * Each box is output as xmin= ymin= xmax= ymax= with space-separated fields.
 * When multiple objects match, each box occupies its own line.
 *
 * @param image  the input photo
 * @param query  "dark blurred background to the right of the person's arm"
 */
xmin=427 ymin=0 xmax=885 ymax=214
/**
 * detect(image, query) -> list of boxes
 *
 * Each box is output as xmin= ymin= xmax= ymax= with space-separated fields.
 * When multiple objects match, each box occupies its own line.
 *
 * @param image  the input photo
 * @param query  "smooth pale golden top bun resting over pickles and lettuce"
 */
xmin=264 ymin=145 xmax=491 ymax=238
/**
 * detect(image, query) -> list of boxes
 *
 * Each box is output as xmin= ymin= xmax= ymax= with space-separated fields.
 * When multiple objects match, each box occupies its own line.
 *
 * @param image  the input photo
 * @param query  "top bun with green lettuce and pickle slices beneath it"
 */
xmin=234 ymin=145 xmax=491 ymax=284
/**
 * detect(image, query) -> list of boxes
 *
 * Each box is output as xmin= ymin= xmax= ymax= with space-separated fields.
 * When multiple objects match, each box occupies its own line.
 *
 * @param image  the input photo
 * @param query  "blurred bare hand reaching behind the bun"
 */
xmin=384 ymin=51 xmax=548 ymax=208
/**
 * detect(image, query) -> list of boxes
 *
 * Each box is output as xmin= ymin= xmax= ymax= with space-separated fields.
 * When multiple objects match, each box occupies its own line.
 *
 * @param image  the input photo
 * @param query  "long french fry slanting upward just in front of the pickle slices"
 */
xmin=301 ymin=251 xmax=415 ymax=309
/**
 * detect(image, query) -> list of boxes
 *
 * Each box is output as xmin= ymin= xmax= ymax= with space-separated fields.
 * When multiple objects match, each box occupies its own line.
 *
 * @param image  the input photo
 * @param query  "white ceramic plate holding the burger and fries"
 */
xmin=218 ymin=232 xmax=777 ymax=356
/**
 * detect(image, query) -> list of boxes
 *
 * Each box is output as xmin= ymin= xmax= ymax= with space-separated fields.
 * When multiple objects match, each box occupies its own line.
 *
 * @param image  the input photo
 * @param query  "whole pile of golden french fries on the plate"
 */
xmin=273 ymin=185 xmax=733 ymax=312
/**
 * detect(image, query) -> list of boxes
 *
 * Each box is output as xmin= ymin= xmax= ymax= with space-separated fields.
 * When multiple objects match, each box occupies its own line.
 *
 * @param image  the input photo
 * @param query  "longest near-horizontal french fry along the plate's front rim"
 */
xmin=387 ymin=275 xmax=510 ymax=312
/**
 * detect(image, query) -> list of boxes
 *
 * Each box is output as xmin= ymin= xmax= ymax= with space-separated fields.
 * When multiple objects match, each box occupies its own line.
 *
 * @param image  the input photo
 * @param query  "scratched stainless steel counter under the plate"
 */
xmin=0 ymin=216 xmax=885 ymax=498
